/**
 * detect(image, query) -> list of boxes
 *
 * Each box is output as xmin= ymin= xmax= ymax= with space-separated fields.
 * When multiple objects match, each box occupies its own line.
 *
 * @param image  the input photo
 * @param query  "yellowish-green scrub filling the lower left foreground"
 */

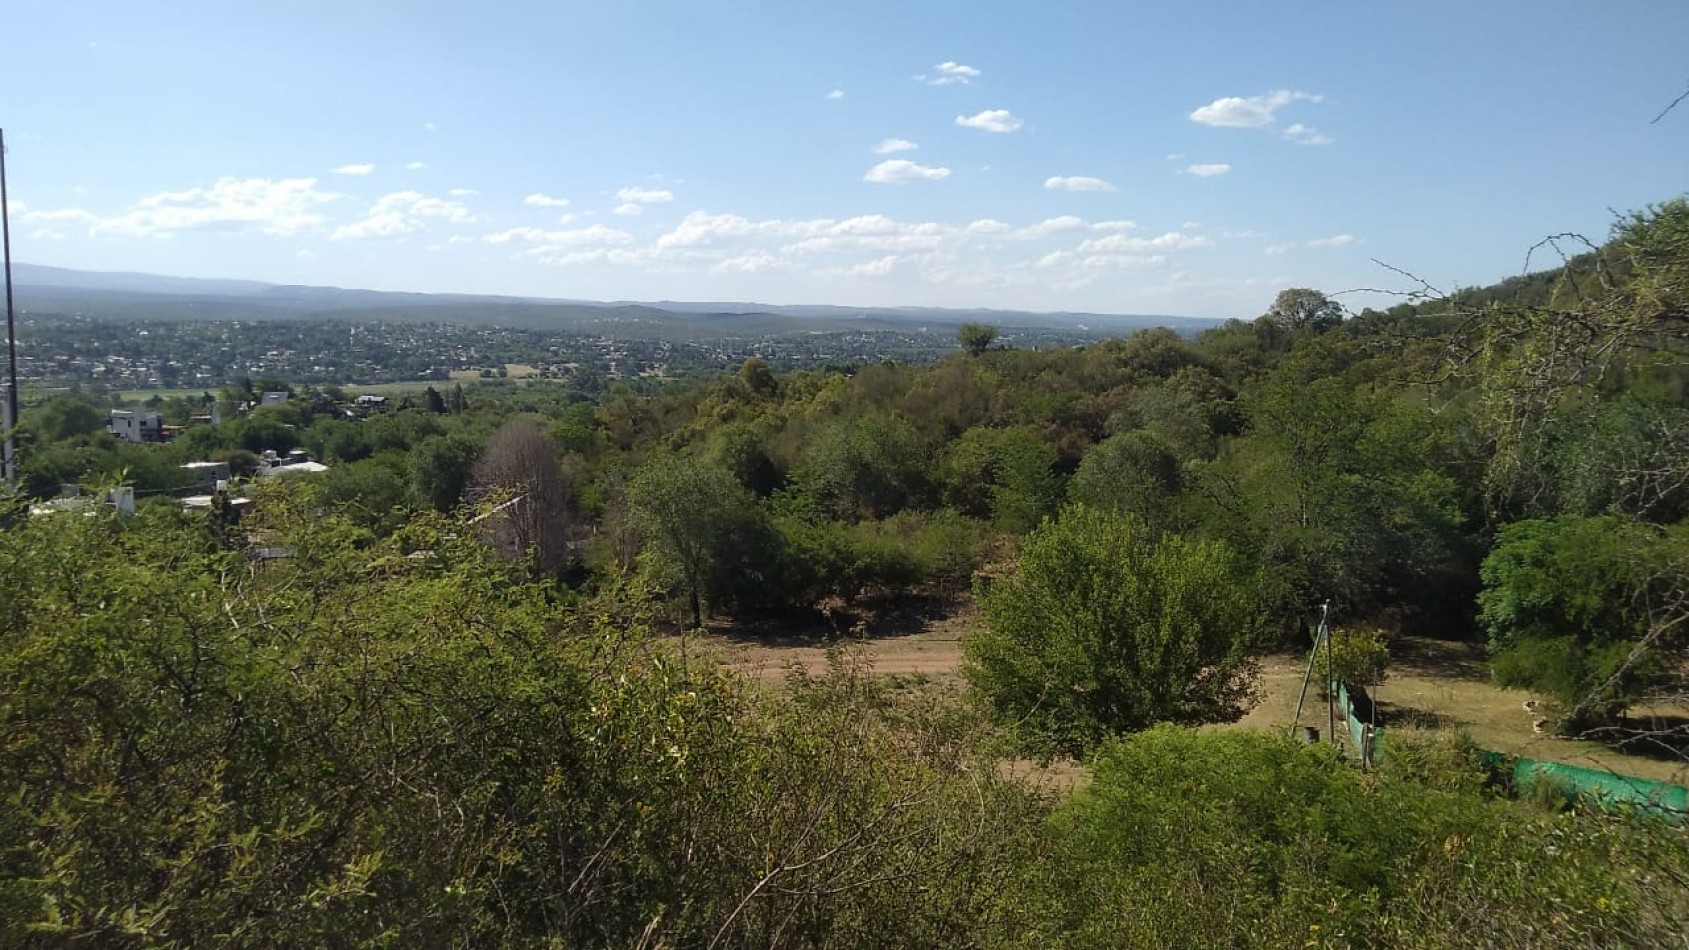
xmin=0 ymin=487 xmax=1039 ymax=947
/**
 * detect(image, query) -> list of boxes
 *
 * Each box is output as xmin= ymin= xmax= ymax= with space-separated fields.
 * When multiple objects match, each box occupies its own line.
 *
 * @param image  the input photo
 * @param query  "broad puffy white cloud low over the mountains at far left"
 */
xmin=90 ymin=177 xmax=341 ymax=237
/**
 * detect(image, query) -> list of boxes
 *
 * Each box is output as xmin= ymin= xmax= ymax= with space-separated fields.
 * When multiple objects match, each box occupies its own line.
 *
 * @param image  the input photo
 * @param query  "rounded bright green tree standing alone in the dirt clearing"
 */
xmin=964 ymin=505 xmax=1262 ymax=754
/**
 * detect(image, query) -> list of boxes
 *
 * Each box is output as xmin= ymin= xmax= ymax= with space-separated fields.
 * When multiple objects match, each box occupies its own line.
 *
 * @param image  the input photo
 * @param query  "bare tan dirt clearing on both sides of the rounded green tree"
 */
xmin=701 ymin=598 xmax=1689 ymax=784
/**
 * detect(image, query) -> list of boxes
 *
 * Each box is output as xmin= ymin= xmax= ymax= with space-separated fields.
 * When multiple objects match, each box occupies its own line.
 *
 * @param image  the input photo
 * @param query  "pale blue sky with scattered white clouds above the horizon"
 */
xmin=0 ymin=0 xmax=1689 ymax=318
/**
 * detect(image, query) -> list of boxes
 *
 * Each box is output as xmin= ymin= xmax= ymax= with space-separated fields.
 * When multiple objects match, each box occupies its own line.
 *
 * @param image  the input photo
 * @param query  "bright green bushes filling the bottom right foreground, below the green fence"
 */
xmin=1022 ymin=727 xmax=1689 ymax=948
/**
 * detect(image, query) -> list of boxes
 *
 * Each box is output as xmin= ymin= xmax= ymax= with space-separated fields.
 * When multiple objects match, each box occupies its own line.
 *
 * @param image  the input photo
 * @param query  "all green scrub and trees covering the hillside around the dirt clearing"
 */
xmin=0 ymin=199 xmax=1689 ymax=947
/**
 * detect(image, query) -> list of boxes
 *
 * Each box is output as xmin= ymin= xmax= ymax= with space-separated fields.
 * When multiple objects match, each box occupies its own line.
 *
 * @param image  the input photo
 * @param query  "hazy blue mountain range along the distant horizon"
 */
xmin=12 ymin=264 xmax=1216 ymax=336
